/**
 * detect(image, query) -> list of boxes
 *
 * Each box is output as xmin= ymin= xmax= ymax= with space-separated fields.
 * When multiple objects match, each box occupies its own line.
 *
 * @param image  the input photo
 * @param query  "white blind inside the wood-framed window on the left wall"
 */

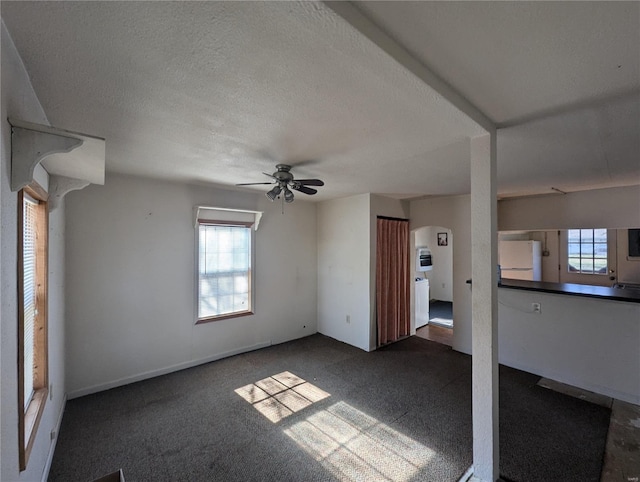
xmin=22 ymin=195 xmax=38 ymax=410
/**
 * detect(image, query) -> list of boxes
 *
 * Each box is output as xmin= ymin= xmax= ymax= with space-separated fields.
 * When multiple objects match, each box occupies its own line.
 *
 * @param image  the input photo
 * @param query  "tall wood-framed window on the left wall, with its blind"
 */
xmin=18 ymin=185 xmax=49 ymax=470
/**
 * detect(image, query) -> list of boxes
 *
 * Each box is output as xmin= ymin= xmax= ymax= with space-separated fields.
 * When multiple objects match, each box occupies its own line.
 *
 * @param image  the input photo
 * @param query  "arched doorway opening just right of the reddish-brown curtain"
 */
xmin=414 ymin=226 xmax=454 ymax=345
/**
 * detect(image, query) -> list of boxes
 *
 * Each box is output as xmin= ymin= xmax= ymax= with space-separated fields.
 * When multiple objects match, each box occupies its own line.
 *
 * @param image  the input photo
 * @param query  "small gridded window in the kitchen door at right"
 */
xmin=567 ymin=229 xmax=607 ymax=275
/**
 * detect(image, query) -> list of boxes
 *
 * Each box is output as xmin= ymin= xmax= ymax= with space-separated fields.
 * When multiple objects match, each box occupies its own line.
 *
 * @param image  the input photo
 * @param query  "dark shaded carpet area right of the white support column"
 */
xmin=500 ymin=366 xmax=611 ymax=482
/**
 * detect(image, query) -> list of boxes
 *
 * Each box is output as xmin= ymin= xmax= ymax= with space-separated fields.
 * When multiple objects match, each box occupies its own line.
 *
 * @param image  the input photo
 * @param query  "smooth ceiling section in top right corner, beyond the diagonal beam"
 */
xmin=357 ymin=1 xmax=640 ymax=124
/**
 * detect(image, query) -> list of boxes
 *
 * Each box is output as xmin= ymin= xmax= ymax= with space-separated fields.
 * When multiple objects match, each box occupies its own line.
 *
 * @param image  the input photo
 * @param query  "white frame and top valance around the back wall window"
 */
xmin=194 ymin=206 xmax=262 ymax=325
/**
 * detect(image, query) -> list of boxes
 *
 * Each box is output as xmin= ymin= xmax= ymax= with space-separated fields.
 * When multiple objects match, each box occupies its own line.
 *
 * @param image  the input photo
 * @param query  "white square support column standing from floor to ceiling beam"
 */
xmin=471 ymin=129 xmax=499 ymax=482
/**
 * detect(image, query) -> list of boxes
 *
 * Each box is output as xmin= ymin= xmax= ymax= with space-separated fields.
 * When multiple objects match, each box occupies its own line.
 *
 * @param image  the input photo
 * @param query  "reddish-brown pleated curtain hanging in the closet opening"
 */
xmin=376 ymin=218 xmax=411 ymax=346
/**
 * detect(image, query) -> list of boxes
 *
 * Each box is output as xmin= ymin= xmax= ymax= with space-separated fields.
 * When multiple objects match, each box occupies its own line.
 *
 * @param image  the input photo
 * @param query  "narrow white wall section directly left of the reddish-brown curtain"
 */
xmin=317 ymin=194 xmax=373 ymax=351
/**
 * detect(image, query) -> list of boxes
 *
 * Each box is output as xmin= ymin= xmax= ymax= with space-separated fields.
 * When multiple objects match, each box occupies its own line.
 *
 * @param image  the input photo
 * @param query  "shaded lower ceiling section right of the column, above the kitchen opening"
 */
xmin=498 ymin=94 xmax=640 ymax=196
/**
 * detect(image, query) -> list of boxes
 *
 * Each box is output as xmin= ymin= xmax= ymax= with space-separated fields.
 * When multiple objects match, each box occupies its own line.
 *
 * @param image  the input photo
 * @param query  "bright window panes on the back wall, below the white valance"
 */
xmin=198 ymin=220 xmax=252 ymax=323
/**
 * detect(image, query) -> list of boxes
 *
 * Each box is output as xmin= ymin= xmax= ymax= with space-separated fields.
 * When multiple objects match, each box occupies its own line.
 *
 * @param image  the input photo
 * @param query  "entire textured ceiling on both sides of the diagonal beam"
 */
xmin=0 ymin=1 xmax=640 ymax=200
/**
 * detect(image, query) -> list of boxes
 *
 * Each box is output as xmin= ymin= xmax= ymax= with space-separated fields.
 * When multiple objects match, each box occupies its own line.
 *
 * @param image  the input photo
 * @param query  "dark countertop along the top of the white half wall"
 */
xmin=498 ymin=279 xmax=640 ymax=303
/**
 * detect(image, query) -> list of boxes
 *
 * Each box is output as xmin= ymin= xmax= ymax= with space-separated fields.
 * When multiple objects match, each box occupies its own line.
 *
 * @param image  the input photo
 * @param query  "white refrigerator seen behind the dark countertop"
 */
xmin=498 ymin=241 xmax=542 ymax=281
